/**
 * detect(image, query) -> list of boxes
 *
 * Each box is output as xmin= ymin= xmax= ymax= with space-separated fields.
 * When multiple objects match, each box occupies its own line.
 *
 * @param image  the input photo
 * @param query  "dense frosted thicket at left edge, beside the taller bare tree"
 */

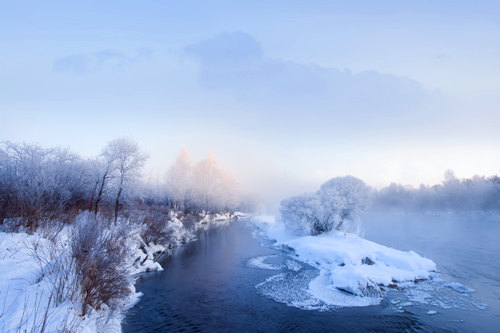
xmin=0 ymin=142 xmax=90 ymax=232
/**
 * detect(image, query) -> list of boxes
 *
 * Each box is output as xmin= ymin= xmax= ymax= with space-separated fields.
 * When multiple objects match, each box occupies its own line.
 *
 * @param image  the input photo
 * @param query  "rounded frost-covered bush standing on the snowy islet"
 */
xmin=280 ymin=176 xmax=370 ymax=235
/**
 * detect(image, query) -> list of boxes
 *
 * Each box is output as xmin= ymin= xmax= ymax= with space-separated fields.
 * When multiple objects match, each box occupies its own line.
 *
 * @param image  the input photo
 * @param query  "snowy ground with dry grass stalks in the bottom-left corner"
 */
xmin=0 ymin=228 xmax=131 ymax=332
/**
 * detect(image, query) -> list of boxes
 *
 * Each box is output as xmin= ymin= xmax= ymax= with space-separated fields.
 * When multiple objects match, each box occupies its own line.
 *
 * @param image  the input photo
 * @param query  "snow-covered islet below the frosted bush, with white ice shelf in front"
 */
xmin=252 ymin=216 xmax=436 ymax=306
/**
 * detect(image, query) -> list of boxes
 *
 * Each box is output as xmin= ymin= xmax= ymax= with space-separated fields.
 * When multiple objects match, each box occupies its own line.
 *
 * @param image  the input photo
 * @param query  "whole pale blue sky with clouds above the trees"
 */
xmin=0 ymin=0 xmax=500 ymax=205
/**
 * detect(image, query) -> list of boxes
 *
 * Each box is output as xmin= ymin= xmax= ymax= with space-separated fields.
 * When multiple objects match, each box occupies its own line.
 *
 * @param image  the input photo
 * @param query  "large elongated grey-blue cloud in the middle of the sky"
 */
xmin=184 ymin=32 xmax=434 ymax=124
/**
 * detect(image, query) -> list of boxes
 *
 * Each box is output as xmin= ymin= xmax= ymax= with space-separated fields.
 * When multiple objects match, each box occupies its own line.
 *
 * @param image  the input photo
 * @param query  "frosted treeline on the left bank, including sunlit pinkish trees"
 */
xmin=0 ymin=138 xmax=239 ymax=233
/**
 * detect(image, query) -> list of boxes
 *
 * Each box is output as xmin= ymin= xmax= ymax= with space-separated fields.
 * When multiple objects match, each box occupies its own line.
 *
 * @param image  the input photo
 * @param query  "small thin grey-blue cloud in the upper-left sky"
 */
xmin=53 ymin=48 xmax=151 ymax=74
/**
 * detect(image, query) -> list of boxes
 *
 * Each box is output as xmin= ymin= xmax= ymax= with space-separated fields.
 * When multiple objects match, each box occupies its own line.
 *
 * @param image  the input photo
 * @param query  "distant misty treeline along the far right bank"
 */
xmin=374 ymin=171 xmax=500 ymax=211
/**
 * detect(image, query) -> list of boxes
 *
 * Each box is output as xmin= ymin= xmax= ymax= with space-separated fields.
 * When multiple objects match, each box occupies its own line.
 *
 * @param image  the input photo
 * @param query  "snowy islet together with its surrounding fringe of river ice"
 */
xmin=251 ymin=216 xmax=486 ymax=312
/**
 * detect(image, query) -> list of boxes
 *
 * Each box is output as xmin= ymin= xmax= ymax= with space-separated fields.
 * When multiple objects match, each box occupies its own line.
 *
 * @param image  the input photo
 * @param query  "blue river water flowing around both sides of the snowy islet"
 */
xmin=123 ymin=214 xmax=500 ymax=332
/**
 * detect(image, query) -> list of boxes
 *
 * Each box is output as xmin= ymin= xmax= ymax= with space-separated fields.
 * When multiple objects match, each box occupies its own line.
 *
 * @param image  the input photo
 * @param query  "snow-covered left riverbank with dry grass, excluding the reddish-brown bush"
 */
xmin=0 ymin=213 xmax=238 ymax=333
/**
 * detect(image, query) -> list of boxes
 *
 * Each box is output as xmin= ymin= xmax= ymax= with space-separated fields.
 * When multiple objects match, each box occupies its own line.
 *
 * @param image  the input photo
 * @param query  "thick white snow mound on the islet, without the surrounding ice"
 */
xmin=286 ymin=231 xmax=436 ymax=296
